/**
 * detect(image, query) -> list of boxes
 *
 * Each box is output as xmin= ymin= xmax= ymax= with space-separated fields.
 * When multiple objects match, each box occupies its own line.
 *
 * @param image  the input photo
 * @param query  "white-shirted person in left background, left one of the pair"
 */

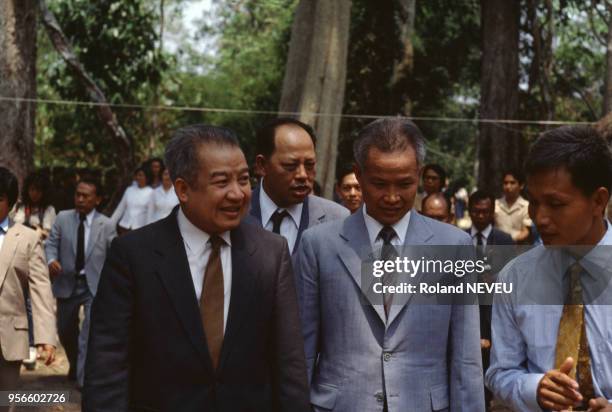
xmin=111 ymin=167 xmax=153 ymax=234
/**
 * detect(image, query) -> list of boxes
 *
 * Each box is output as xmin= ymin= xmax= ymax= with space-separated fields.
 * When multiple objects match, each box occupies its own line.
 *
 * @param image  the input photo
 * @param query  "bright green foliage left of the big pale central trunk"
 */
xmin=172 ymin=0 xmax=297 ymax=163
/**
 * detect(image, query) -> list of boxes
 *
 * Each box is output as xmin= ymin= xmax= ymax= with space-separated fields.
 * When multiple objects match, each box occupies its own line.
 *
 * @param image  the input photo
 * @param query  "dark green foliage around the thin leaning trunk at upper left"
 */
xmin=37 ymin=0 xmax=171 ymax=171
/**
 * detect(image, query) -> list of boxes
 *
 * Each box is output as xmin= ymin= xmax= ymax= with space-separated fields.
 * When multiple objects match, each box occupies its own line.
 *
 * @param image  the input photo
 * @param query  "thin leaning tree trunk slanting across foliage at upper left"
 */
xmin=38 ymin=0 xmax=134 ymax=213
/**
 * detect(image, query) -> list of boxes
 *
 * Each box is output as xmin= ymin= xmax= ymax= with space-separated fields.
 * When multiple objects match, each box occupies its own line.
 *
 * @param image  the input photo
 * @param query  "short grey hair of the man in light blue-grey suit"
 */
xmin=353 ymin=117 xmax=425 ymax=170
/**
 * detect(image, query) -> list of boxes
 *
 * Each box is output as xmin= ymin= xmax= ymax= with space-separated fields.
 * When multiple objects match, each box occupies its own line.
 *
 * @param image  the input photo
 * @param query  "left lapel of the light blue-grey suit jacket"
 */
xmin=338 ymin=209 xmax=385 ymax=324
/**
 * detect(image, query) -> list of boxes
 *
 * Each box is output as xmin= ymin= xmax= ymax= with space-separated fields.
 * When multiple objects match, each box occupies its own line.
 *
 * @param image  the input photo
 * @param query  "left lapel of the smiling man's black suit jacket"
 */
xmin=155 ymin=211 xmax=212 ymax=370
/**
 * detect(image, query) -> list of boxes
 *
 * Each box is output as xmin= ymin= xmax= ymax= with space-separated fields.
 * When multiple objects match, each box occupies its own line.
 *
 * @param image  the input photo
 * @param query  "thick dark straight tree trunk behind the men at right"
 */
xmin=478 ymin=0 xmax=525 ymax=195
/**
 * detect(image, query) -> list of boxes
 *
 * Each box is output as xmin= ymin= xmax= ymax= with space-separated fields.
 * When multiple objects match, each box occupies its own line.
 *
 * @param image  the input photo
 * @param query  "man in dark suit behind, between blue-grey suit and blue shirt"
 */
xmin=467 ymin=190 xmax=514 ymax=405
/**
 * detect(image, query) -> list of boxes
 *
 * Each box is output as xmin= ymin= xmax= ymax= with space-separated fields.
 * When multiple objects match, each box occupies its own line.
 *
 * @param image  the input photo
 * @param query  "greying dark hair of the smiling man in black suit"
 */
xmin=164 ymin=124 xmax=240 ymax=187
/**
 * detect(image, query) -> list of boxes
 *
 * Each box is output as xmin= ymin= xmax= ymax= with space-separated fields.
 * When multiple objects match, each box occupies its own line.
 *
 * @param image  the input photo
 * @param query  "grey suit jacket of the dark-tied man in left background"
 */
xmin=45 ymin=209 xmax=117 ymax=298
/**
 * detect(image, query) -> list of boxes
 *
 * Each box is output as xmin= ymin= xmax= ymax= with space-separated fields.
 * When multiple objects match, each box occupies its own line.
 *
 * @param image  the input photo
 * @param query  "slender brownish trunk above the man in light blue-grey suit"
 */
xmin=391 ymin=0 xmax=416 ymax=116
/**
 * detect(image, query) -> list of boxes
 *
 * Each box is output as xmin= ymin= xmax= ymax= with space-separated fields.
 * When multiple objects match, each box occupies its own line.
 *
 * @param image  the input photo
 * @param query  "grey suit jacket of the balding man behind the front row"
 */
xmin=247 ymin=186 xmax=351 ymax=255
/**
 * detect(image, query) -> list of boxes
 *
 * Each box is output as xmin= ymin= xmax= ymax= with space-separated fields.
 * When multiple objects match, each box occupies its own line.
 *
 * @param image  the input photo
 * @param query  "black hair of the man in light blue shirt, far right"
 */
xmin=525 ymin=126 xmax=612 ymax=196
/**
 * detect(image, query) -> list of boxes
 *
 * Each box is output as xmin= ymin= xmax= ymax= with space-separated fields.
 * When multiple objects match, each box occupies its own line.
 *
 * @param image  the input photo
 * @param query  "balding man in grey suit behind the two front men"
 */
xmin=250 ymin=118 xmax=350 ymax=254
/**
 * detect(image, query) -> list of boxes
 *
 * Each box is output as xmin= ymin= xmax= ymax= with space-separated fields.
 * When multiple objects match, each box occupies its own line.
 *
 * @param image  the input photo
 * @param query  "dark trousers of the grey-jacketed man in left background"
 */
xmin=57 ymin=276 xmax=93 ymax=387
